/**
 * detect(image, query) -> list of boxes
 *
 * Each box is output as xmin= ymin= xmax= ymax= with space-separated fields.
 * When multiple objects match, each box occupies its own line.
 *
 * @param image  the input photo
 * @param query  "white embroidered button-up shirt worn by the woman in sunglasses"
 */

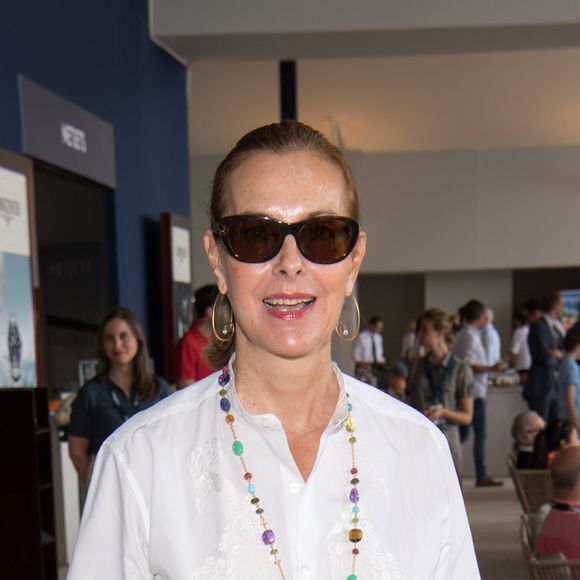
xmin=68 ymin=360 xmax=480 ymax=580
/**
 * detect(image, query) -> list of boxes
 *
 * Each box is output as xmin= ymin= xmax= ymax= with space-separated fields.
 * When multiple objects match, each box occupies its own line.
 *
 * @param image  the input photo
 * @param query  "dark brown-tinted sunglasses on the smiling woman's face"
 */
xmin=212 ymin=215 xmax=359 ymax=264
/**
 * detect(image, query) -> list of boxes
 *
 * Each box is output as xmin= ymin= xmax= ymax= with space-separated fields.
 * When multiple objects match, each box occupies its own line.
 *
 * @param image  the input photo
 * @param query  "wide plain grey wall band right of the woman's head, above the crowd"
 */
xmin=349 ymin=147 xmax=580 ymax=273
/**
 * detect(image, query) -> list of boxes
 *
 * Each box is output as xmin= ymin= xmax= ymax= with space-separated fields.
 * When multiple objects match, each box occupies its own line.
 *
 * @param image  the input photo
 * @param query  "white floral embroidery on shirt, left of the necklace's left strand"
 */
xmin=190 ymin=439 xmax=277 ymax=580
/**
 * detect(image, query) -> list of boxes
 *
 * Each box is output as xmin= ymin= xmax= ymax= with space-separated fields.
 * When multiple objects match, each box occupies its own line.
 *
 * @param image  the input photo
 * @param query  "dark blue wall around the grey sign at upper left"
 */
xmin=0 ymin=0 xmax=189 ymax=358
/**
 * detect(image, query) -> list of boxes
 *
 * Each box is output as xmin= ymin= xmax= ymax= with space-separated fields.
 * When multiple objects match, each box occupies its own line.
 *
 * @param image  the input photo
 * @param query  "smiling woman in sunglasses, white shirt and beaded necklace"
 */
xmin=69 ymin=121 xmax=479 ymax=580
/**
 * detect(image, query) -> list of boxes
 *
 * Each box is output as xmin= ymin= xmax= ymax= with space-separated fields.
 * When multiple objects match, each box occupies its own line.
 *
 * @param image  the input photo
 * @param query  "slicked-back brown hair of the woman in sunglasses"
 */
xmin=205 ymin=121 xmax=360 ymax=368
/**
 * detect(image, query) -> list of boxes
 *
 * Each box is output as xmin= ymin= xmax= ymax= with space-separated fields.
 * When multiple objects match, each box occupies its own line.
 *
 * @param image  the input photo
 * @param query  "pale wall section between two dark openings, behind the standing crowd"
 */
xmin=425 ymin=270 xmax=513 ymax=356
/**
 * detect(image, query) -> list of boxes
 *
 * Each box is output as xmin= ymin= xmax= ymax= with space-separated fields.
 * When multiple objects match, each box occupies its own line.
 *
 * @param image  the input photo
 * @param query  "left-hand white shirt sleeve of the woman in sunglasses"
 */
xmin=67 ymin=443 xmax=154 ymax=580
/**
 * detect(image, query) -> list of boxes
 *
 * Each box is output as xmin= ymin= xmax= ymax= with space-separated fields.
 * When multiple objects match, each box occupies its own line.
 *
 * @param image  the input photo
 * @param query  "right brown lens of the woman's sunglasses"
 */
xmin=299 ymin=218 xmax=356 ymax=264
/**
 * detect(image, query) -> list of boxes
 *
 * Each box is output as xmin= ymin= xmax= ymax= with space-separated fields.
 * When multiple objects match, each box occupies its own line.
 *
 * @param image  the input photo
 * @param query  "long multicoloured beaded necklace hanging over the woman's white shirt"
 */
xmin=218 ymin=367 xmax=363 ymax=580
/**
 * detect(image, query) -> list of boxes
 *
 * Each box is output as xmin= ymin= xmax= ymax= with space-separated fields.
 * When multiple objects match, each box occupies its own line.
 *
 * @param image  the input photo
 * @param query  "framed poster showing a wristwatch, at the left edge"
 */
xmin=0 ymin=149 xmax=42 ymax=388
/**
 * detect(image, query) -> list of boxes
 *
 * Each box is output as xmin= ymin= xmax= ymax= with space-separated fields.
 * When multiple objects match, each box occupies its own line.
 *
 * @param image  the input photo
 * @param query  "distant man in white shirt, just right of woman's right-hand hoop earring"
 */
xmin=353 ymin=316 xmax=386 ymax=387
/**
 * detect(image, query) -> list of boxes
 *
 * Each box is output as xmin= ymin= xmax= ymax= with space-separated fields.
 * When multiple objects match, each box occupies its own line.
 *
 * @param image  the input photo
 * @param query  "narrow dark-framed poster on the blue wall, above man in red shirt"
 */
xmin=161 ymin=213 xmax=193 ymax=381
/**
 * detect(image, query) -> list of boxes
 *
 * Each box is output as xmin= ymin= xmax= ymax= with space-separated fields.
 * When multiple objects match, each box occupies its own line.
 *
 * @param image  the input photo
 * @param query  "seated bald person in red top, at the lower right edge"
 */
xmin=536 ymin=447 xmax=580 ymax=560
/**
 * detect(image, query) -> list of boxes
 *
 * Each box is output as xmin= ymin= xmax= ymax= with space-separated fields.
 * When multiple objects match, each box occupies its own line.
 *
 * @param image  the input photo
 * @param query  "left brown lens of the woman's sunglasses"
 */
xmin=228 ymin=218 xmax=280 ymax=262
